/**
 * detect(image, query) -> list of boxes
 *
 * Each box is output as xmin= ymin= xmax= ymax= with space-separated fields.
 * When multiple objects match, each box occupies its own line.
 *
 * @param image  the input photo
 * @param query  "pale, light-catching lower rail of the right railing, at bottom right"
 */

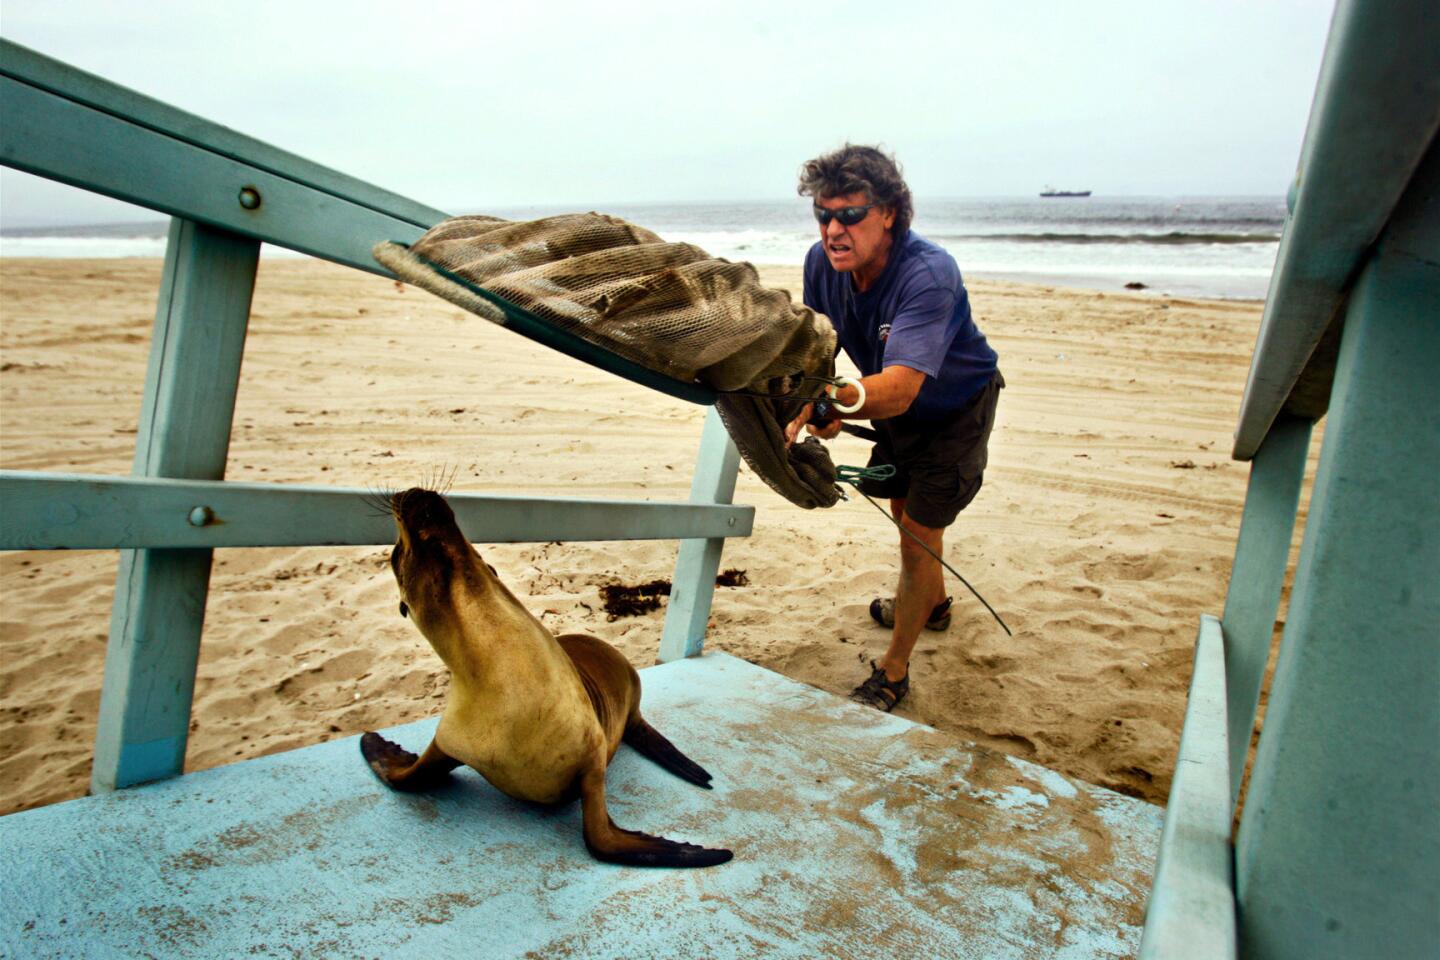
xmin=1140 ymin=616 xmax=1237 ymax=960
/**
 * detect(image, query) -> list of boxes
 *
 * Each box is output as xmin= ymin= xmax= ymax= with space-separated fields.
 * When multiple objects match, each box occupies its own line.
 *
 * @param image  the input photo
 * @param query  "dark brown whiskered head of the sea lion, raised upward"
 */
xmin=390 ymin=486 xmax=508 ymax=640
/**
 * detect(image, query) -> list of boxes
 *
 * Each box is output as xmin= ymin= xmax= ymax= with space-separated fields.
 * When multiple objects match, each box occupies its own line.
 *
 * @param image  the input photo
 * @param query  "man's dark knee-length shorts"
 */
xmin=860 ymin=370 xmax=1005 ymax=530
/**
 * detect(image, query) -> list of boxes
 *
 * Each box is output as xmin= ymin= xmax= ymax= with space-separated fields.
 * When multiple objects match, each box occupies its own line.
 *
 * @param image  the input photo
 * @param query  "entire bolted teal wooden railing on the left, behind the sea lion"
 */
xmin=0 ymin=40 xmax=753 ymax=790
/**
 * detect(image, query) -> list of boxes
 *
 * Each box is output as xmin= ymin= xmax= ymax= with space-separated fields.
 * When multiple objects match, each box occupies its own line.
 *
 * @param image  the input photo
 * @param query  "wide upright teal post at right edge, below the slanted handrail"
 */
xmin=1236 ymin=163 xmax=1440 ymax=960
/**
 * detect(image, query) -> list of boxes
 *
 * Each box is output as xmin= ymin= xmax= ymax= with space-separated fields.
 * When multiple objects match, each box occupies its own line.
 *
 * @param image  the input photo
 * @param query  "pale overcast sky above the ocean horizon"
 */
xmin=0 ymin=0 xmax=1333 ymax=226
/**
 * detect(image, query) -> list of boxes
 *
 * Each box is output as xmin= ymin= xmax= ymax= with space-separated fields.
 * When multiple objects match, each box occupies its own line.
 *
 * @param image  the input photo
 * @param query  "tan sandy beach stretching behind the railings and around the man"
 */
xmin=0 ymin=258 xmax=1313 ymax=813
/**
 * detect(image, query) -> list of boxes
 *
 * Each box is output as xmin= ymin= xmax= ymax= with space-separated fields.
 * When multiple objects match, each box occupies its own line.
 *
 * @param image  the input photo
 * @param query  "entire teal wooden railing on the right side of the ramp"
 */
xmin=1140 ymin=0 xmax=1440 ymax=960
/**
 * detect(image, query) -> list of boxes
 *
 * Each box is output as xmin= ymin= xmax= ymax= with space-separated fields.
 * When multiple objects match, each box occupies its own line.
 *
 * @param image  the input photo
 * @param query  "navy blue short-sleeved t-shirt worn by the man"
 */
xmin=805 ymin=230 xmax=999 ymax=420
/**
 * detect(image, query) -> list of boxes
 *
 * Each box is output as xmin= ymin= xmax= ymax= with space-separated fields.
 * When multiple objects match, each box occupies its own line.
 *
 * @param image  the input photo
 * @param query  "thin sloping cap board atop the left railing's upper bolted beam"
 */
xmin=0 ymin=39 xmax=446 ymax=227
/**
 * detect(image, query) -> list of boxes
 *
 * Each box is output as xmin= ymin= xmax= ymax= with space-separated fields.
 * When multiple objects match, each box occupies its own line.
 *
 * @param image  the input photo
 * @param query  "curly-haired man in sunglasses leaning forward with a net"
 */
xmin=785 ymin=144 xmax=1005 ymax=711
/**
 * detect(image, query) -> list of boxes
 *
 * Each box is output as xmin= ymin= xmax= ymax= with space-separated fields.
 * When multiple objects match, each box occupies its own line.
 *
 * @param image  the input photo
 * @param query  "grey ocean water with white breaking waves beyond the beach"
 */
xmin=0 ymin=197 xmax=1284 ymax=299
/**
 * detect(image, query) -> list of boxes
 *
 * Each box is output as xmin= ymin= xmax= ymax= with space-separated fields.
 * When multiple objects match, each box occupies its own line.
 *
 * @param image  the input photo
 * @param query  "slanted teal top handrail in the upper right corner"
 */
xmin=1234 ymin=0 xmax=1440 ymax=461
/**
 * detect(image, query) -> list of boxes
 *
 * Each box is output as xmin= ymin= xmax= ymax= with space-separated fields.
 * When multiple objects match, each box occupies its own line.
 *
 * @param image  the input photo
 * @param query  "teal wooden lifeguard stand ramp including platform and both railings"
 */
xmin=0 ymin=0 xmax=1440 ymax=959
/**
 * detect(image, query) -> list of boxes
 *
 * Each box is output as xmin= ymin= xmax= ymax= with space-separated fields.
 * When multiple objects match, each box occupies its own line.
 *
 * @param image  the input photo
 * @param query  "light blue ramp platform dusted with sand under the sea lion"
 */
xmin=0 ymin=653 xmax=1162 ymax=960
